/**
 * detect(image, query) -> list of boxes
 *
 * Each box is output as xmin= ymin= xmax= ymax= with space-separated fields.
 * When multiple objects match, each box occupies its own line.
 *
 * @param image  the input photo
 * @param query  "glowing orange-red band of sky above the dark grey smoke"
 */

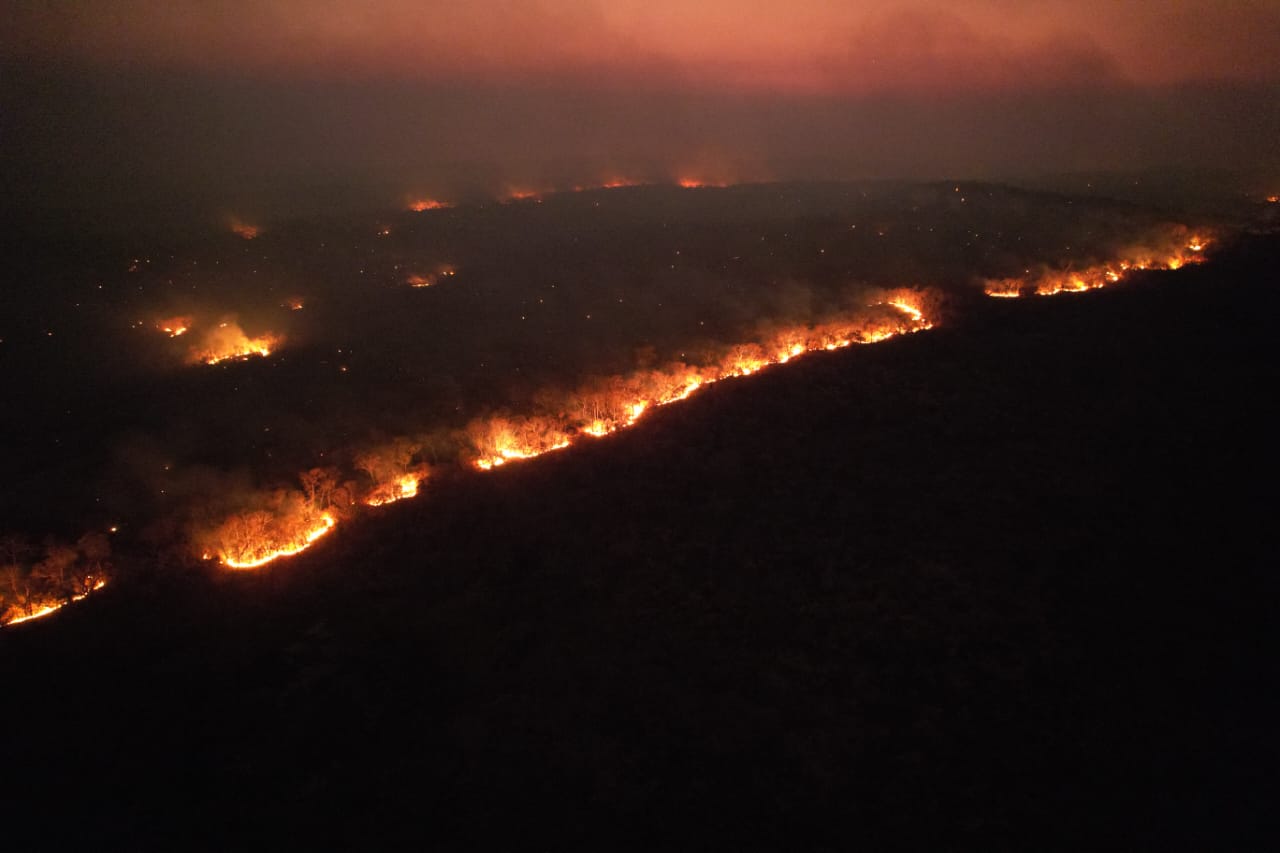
xmin=4 ymin=0 xmax=1280 ymax=92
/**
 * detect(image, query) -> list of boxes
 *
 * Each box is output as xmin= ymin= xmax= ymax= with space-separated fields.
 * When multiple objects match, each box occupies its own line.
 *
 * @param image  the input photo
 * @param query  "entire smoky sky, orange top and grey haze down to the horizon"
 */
xmin=0 ymin=0 xmax=1280 ymax=219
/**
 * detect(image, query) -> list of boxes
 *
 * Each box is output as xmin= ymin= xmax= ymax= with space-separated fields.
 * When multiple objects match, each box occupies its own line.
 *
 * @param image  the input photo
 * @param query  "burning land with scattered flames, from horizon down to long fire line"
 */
xmin=0 ymin=175 xmax=1233 ymax=622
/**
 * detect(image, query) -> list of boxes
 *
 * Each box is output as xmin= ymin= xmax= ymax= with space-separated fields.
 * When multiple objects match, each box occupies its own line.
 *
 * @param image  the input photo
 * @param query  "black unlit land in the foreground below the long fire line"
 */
xmin=0 ymin=237 xmax=1280 ymax=850
